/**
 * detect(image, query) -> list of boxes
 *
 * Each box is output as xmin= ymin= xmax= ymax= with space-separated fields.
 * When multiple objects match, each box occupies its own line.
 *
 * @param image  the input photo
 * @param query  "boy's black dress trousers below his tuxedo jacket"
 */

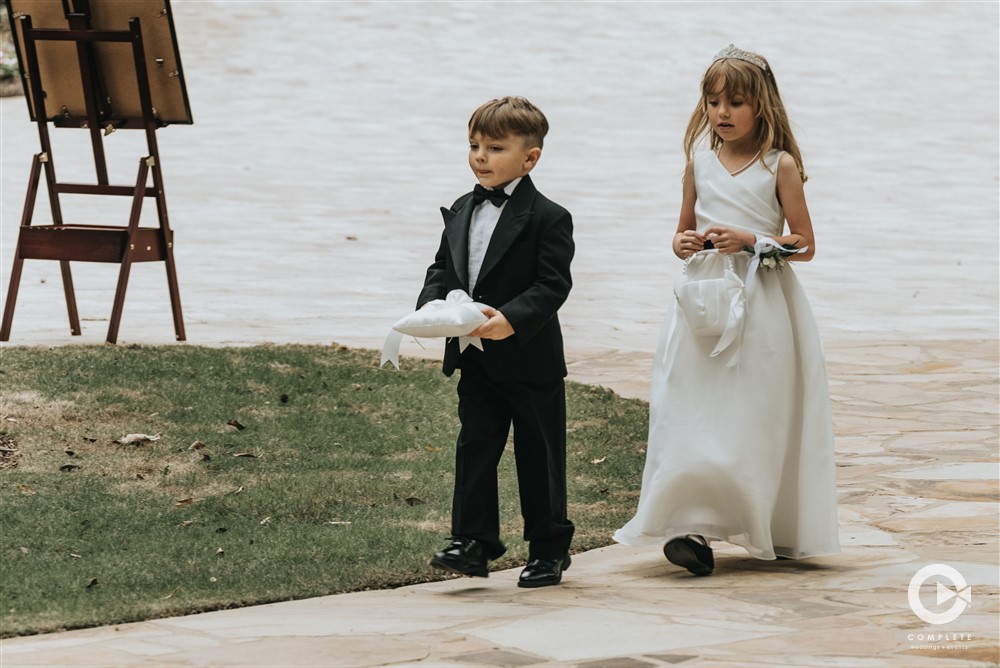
xmin=451 ymin=349 xmax=573 ymax=559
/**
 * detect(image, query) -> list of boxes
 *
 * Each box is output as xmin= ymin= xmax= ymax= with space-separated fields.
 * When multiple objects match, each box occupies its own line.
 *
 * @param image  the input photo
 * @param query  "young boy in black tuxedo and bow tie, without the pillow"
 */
xmin=417 ymin=97 xmax=574 ymax=587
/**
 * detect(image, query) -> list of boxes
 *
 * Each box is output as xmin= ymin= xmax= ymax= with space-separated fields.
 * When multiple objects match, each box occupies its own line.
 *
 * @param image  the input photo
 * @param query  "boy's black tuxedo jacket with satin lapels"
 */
xmin=417 ymin=176 xmax=574 ymax=382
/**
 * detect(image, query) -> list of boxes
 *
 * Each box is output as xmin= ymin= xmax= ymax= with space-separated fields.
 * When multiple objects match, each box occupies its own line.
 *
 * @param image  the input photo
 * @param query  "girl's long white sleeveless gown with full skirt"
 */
xmin=614 ymin=151 xmax=840 ymax=559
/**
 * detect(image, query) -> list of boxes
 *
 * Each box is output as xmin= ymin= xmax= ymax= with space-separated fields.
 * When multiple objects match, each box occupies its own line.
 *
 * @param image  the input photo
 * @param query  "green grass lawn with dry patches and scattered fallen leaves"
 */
xmin=0 ymin=346 xmax=648 ymax=636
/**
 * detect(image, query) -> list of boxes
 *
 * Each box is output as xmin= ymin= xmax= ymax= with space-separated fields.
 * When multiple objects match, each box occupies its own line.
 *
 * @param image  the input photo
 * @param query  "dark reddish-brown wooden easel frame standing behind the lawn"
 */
xmin=0 ymin=0 xmax=186 ymax=343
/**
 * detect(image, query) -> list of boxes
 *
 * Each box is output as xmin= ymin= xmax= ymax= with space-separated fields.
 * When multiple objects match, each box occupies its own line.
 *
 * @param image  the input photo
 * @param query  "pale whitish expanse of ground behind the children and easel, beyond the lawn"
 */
xmin=0 ymin=0 xmax=1000 ymax=351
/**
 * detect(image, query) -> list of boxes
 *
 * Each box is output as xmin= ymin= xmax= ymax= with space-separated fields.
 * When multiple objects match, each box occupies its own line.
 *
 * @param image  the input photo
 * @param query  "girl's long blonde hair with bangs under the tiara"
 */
xmin=684 ymin=52 xmax=808 ymax=183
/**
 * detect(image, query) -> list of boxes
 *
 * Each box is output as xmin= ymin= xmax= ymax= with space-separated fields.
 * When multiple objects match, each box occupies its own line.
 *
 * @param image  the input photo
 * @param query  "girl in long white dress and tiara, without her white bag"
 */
xmin=614 ymin=45 xmax=840 ymax=575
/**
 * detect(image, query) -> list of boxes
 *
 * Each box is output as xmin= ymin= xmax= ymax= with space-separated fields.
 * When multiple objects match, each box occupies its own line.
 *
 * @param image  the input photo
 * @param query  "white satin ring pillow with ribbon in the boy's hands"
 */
xmin=379 ymin=290 xmax=489 ymax=369
